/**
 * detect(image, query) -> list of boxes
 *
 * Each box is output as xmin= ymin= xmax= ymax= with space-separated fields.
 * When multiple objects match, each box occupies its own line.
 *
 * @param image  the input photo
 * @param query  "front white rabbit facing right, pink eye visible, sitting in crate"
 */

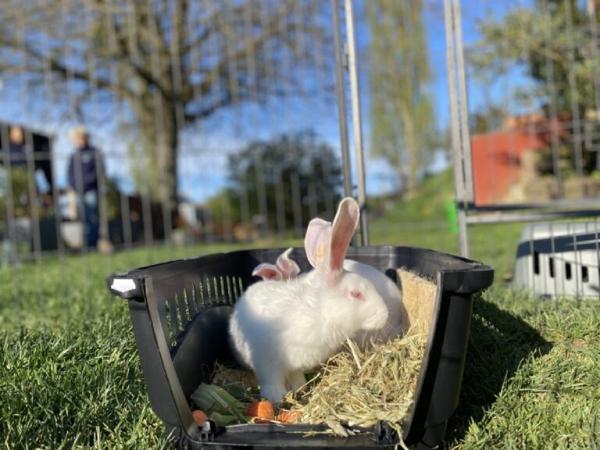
xmin=229 ymin=199 xmax=388 ymax=403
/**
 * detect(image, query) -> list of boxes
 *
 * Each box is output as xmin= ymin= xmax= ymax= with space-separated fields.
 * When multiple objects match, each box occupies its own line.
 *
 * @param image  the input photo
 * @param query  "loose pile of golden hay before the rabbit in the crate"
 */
xmin=286 ymin=326 xmax=427 ymax=427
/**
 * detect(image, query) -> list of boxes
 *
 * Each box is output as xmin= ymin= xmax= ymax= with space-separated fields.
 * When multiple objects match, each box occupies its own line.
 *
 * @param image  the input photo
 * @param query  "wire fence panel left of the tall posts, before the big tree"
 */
xmin=0 ymin=0 xmax=378 ymax=263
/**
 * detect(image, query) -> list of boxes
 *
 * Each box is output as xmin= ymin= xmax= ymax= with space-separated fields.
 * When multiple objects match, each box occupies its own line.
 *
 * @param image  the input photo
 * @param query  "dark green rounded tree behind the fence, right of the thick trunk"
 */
xmin=210 ymin=131 xmax=341 ymax=229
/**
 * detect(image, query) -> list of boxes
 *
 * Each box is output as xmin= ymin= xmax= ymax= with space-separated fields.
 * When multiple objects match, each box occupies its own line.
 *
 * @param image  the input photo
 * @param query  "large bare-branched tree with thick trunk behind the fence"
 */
xmin=0 ymin=0 xmax=327 ymax=207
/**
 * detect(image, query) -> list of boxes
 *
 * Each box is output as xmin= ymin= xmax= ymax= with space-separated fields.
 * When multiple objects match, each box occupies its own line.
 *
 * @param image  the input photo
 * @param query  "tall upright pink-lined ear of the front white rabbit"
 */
xmin=329 ymin=197 xmax=360 ymax=276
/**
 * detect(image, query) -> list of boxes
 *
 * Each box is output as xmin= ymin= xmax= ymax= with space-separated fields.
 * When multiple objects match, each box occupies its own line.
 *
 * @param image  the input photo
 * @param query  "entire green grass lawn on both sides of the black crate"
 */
xmin=0 ymin=177 xmax=600 ymax=449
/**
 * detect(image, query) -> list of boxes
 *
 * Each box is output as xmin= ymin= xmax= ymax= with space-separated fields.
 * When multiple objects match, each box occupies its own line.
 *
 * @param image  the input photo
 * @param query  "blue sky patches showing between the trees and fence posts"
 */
xmin=0 ymin=0 xmax=530 ymax=201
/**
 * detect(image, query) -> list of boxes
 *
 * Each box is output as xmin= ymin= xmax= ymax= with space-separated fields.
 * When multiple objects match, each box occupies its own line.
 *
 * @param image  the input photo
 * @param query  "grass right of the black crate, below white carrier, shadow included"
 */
xmin=451 ymin=287 xmax=600 ymax=449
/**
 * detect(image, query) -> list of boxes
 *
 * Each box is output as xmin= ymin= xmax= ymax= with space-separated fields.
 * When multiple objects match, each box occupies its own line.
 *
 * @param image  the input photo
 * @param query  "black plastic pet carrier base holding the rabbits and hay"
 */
xmin=108 ymin=246 xmax=494 ymax=448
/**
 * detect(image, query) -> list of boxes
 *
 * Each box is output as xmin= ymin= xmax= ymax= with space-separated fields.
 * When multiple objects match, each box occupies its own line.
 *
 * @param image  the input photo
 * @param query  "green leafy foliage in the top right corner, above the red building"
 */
xmin=469 ymin=0 xmax=600 ymax=112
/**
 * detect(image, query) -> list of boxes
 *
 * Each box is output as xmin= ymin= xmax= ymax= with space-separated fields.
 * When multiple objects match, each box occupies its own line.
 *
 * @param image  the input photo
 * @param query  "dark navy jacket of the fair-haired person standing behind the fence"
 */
xmin=67 ymin=145 xmax=104 ymax=193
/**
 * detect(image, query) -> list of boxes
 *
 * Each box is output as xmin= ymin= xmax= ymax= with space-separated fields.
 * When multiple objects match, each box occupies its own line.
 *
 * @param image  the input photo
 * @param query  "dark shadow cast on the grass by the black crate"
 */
xmin=446 ymin=298 xmax=552 ymax=446
